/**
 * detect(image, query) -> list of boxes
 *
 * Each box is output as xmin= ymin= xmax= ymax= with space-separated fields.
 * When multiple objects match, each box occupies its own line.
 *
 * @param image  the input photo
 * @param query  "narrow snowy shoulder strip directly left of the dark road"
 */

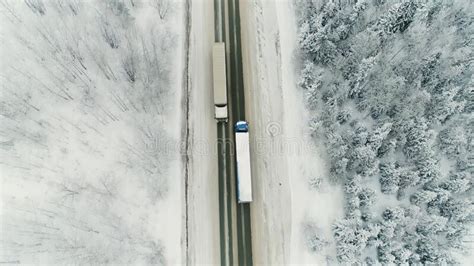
xmin=187 ymin=0 xmax=220 ymax=265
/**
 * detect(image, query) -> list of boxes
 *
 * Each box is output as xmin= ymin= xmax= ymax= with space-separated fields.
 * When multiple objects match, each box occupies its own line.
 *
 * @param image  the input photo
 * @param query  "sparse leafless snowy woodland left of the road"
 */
xmin=0 ymin=0 xmax=184 ymax=265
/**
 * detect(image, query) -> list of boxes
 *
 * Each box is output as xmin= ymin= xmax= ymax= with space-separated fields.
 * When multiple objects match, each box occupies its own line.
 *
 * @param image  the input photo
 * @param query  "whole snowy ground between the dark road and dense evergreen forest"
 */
xmin=241 ymin=1 xmax=343 ymax=265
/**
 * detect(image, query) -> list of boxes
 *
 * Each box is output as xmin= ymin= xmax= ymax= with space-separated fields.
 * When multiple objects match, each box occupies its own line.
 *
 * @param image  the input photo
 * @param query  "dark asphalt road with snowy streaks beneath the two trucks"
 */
xmin=214 ymin=0 xmax=252 ymax=265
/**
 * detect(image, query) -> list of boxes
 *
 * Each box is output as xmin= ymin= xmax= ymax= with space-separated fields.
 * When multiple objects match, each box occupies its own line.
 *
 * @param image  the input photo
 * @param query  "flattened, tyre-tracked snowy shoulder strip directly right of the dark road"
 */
xmin=241 ymin=1 xmax=291 ymax=265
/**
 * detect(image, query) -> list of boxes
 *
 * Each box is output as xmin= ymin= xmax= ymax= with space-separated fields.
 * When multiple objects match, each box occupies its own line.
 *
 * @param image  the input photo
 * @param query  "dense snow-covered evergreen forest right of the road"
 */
xmin=297 ymin=0 xmax=474 ymax=265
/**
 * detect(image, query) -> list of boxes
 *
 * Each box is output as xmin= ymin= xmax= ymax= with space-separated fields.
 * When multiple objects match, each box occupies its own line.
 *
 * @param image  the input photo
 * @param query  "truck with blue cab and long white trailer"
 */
xmin=235 ymin=121 xmax=252 ymax=203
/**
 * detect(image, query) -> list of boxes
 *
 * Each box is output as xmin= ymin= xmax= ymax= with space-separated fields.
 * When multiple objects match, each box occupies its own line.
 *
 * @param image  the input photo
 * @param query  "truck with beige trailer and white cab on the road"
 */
xmin=212 ymin=42 xmax=227 ymax=120
